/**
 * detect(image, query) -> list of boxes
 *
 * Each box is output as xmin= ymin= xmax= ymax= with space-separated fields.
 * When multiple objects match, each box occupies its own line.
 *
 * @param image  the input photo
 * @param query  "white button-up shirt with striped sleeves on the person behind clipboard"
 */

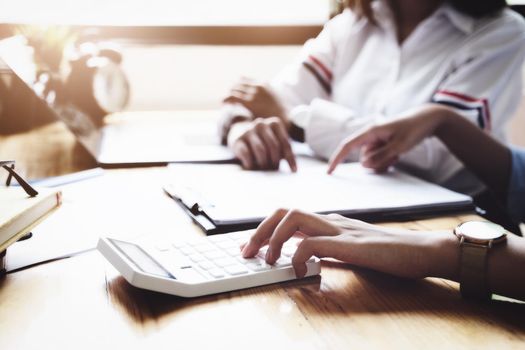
xmin=271 ymin=0 xmax=525 ymax=194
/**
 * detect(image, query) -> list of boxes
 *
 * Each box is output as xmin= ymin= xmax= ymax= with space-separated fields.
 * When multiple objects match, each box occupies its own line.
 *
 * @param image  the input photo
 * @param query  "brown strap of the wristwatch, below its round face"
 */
xmin=459 ymin=240 xmax=492 ymax=300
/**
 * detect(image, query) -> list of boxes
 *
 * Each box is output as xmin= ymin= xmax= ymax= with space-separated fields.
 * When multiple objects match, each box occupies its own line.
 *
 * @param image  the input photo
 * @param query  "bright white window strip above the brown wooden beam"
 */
xmin=0 ymin=0 xmax=329 ymax=26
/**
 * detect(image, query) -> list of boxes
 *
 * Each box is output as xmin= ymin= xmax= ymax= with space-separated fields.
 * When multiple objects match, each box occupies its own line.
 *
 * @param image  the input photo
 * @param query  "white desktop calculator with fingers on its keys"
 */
xmin=97 ymin=231 xmax=321 ymax=297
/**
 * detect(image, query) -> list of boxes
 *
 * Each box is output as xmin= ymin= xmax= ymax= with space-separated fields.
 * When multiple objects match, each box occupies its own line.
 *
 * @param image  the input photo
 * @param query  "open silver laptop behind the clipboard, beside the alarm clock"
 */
xmin=0 ymin=36 xmax=234 ymax=168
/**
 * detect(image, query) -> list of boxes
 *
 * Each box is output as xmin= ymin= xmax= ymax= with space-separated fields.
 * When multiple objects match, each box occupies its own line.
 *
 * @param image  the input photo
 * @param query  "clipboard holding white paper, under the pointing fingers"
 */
xmin=164 ymin=157 xmax=473 ymax=234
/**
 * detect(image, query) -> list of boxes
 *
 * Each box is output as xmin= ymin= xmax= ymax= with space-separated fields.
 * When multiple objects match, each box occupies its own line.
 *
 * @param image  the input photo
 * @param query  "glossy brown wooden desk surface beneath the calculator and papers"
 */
xmin=0 ymin=119 xmax=525 ymax=349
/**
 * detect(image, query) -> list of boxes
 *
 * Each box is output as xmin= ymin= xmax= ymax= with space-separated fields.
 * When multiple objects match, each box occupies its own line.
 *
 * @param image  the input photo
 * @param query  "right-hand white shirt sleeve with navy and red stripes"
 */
xmin=432 ymin=16 xmax=525 ymax=138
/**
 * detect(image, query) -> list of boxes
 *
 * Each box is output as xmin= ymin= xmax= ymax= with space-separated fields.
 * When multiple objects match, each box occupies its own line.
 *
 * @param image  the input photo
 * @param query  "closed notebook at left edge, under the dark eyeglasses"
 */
xmin=0 ymin=186 xmax=62 ymax=252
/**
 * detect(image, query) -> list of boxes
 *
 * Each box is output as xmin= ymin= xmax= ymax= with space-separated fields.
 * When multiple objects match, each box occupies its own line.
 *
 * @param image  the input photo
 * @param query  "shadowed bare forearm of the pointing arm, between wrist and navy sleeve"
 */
xmin=435 ymin=110 xmax=512 ymax=197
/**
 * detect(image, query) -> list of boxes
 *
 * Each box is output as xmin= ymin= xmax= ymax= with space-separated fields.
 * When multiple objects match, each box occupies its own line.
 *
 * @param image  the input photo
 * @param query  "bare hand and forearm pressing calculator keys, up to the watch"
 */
xmin=242 ymin=209 xmax=446 ymax=278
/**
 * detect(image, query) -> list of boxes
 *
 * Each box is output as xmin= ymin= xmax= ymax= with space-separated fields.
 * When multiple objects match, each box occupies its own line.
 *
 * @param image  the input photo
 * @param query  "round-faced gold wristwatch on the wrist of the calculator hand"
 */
xmin=454 ymin=221 xmax=507 ymax=300
